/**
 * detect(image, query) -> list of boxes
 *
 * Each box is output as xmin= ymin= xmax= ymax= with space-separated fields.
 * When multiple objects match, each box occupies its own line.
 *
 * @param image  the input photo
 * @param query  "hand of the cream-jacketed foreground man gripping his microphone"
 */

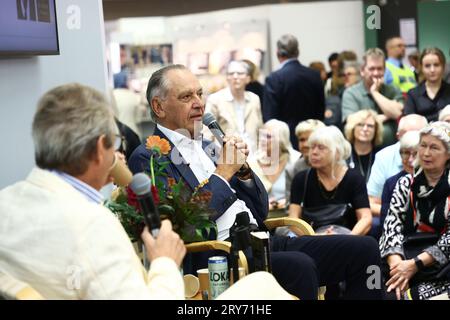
xmin=141 ymin=220 xmax=186 ymax=267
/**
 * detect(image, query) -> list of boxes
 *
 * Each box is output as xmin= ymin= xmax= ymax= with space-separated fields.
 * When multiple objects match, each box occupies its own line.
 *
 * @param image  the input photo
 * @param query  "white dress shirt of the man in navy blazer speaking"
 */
xmin=157 ymin=124 xmax=258 ymax=240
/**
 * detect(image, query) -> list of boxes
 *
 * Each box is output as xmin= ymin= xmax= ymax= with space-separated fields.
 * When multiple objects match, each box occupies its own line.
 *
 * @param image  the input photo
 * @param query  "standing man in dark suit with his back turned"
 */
xmin=263 ymin=34 xmax=325 ymax=149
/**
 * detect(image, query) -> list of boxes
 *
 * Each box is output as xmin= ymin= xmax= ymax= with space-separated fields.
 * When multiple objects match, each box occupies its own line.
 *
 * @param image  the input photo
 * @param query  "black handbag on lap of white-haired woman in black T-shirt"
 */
xmin=301 ymin=169 xmax=353 ymax=230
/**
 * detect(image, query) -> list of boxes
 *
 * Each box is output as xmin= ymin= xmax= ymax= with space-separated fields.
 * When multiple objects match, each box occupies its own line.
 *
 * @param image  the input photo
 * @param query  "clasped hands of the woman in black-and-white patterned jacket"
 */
xmin=386 ymin=260 xmax=417 ymax=300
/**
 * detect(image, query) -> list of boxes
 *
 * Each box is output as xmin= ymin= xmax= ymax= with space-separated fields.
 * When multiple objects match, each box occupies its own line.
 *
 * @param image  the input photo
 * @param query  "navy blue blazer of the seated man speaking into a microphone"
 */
xmin=128 ymin=128 xmax=269 ymax=230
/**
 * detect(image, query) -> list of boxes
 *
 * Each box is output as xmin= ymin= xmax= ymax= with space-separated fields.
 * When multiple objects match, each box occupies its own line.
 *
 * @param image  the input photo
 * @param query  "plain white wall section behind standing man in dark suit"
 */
xmin=269 ymin=1 xmax=364 ymax=68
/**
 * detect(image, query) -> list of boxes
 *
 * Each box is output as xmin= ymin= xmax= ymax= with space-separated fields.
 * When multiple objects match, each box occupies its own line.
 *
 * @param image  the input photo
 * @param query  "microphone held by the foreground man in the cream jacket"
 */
xmin=130 ymin=173 xmax=161 ymax=238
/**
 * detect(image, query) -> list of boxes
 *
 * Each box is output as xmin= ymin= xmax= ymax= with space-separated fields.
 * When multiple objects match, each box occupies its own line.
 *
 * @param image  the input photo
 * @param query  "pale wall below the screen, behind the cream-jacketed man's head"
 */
xmin=0 ymin=0 xmax=108 ymax=188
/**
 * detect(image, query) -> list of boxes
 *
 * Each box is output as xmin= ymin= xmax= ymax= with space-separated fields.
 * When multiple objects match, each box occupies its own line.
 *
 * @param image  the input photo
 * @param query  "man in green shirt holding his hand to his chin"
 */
xmin=342 ymin=48 xmax=403 ymax=146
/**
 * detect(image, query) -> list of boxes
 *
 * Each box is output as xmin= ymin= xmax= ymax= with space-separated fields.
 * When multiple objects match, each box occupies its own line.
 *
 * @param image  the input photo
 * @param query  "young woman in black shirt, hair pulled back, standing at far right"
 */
xmin=404 ymin=48 xmax=450 ymax=122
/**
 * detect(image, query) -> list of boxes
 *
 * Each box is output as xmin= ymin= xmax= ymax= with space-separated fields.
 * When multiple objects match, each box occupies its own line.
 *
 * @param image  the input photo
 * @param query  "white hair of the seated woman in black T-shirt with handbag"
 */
xmin=308 ymin=126 xmax=352 ymax=166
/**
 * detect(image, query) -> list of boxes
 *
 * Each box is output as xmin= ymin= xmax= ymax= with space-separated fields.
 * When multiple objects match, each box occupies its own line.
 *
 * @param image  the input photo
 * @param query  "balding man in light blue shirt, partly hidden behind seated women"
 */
xmin=367 ymin=114 xmax=428 ymax=225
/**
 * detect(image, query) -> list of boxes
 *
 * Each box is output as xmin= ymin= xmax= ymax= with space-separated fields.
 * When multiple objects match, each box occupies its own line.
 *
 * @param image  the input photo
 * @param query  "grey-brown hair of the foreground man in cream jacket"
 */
xmin=32 ymin=83 xmax=118 ymax=176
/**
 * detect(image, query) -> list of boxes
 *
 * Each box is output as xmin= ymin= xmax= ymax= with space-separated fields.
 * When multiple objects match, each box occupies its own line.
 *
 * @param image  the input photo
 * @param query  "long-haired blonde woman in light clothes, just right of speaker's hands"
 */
xmin=249 ymin=119 xmax=300 ymax=214
